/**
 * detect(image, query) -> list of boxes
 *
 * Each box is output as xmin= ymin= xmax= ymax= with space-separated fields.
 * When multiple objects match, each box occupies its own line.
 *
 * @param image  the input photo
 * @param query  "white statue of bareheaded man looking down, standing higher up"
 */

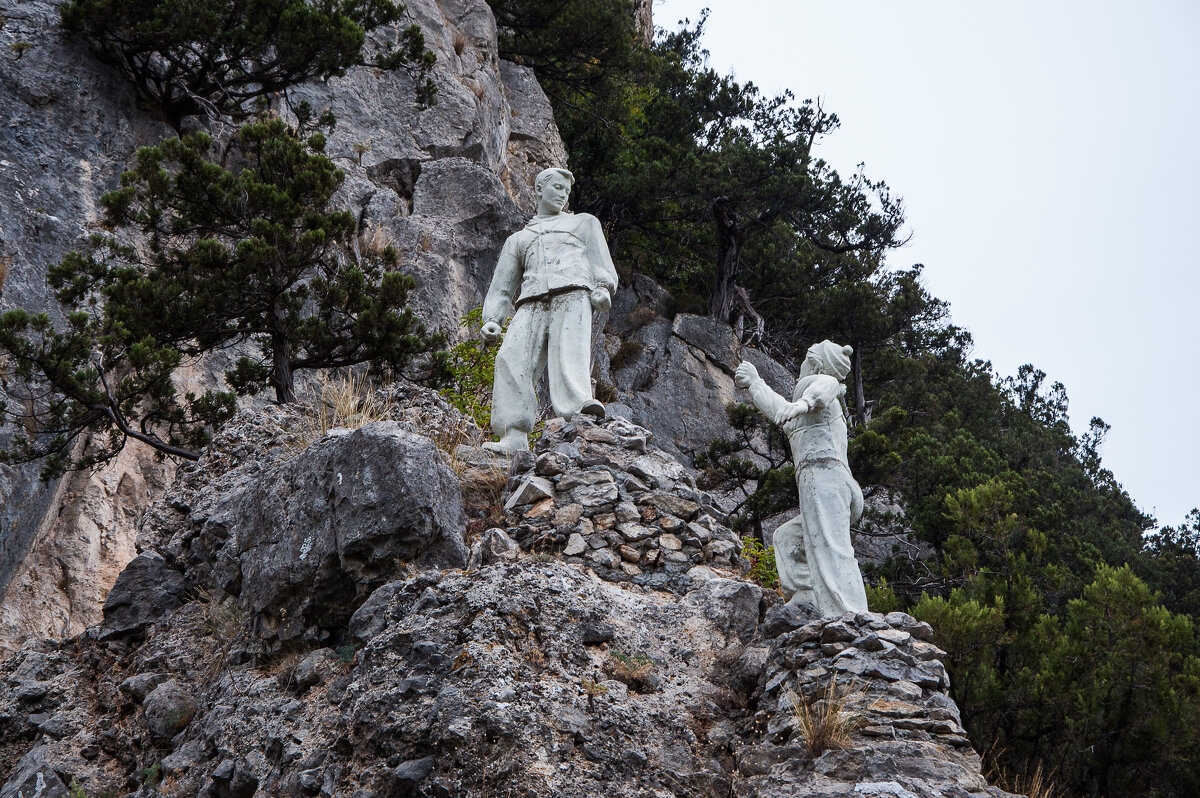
xmin=480 ymin=169 xmax=617 ymax=454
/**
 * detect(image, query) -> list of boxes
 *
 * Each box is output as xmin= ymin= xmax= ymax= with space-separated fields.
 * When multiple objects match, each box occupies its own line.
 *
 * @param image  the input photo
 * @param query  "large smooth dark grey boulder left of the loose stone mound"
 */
xmin=190 ymin=421 xmax=467 ymax=641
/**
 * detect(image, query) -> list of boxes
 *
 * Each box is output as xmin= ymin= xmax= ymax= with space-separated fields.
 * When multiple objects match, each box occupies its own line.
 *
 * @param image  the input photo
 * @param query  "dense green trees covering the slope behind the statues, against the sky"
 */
xmin=491 ymin=0 xmax=1200 ymax=796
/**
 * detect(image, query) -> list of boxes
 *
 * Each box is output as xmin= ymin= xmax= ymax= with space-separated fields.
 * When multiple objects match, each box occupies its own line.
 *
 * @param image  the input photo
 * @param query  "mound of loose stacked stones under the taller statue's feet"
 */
xmin=472 ymin=416 xmax=745 ymax=592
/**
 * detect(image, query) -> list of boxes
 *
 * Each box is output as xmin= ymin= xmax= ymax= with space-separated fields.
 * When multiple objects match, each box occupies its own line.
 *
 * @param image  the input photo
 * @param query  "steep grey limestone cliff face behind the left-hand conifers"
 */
xmin=0 ymin=0 xmax=566 ymax=650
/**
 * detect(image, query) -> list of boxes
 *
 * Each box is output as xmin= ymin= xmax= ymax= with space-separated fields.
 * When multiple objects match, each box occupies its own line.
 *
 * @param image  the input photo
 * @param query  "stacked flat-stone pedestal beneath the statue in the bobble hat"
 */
xmin=738 ymin=606 xmax=1008 ymax=798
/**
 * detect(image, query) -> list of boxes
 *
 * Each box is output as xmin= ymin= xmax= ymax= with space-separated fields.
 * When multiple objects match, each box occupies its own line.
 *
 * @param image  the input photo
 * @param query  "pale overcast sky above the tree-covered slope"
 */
xmin=654 ymin=0 xmax=1200 ymax=524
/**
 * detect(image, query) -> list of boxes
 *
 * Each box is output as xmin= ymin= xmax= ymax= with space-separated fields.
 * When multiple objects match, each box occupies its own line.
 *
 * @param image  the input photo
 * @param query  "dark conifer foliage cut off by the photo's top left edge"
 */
xmin=61 ymin=0 xmax=433 ymax=128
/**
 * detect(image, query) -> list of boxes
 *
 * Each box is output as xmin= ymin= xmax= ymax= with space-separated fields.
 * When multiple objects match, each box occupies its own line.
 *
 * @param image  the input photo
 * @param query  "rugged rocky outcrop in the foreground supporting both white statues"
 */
xmin=0 ymin=388 xmax=1004 ymax=798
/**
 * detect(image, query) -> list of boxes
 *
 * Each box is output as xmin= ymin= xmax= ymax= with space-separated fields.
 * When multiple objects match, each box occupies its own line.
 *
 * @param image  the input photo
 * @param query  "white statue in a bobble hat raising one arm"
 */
xmin=734 ymin=341 xmax=866 ymax=617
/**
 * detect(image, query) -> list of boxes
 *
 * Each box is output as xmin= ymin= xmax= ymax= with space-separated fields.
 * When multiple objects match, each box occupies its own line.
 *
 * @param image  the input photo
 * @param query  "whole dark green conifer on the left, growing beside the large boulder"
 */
xmin=0 ymin=108 xmax=440 ymax=479
